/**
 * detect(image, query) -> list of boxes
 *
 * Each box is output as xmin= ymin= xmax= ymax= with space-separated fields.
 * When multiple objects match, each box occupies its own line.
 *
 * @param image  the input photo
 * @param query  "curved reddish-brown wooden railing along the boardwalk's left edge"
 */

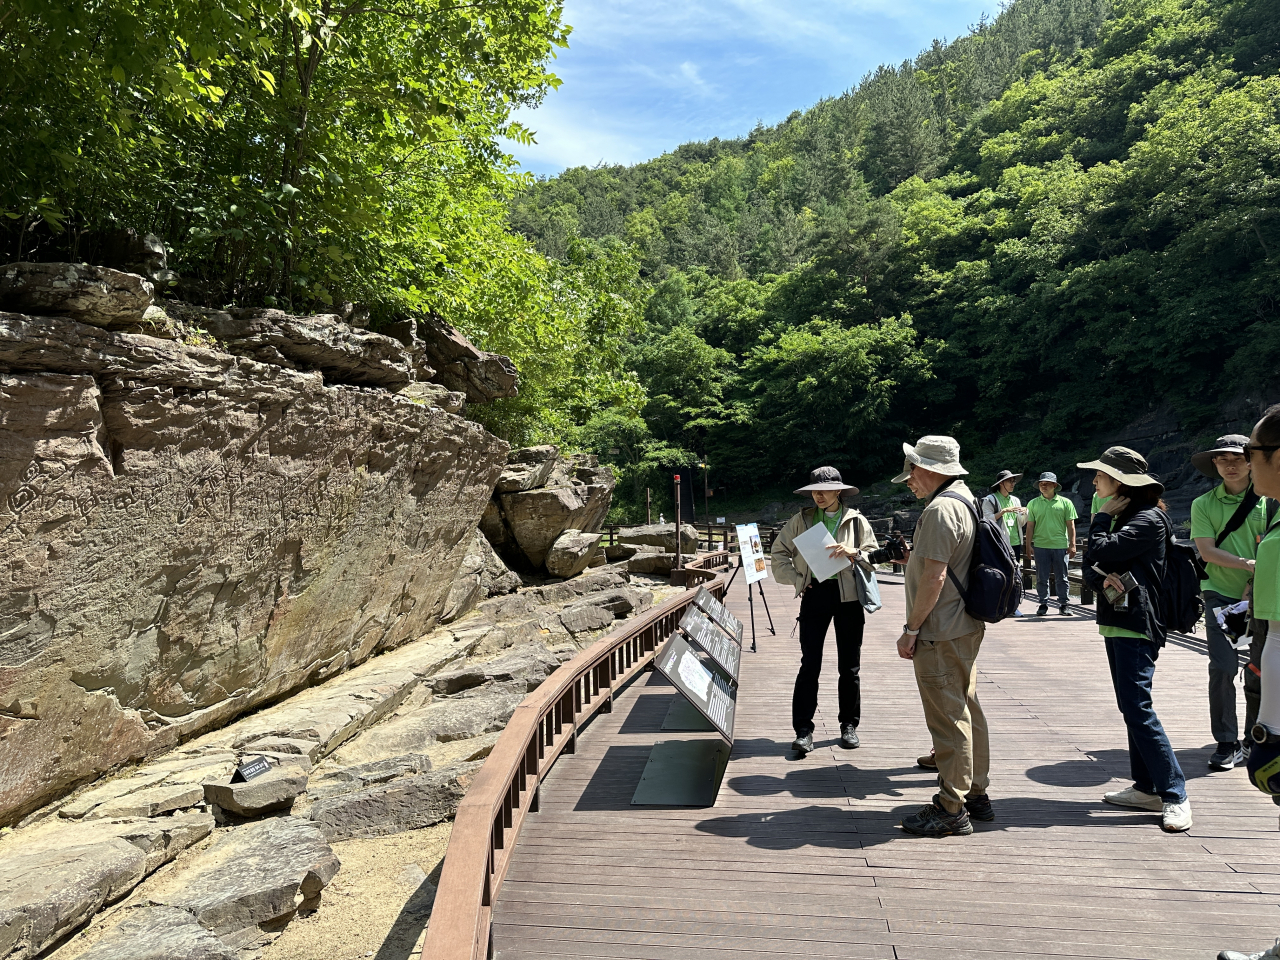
xmin=422 ymin=568 xmax=728 ymax=960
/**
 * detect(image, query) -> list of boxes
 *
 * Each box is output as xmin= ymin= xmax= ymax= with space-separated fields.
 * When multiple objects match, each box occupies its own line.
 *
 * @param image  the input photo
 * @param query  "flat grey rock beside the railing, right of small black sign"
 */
xmin=311 ymin=762 xmax=483 ymax=841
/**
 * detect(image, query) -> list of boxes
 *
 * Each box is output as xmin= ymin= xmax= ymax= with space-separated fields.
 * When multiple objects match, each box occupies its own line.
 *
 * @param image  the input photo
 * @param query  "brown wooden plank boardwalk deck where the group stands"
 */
xmin=493 ymin=577 xmax=1280 ymax=960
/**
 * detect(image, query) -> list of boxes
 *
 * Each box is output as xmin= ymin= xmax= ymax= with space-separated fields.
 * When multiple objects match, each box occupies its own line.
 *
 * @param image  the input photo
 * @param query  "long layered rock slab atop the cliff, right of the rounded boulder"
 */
xmin=204 ymin=310 xmax=413 ymax=390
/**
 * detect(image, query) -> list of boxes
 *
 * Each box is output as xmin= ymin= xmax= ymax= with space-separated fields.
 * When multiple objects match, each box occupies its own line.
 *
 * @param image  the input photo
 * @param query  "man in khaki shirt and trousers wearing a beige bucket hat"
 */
xmin=893 ymin=436 xmax=996 ymax=837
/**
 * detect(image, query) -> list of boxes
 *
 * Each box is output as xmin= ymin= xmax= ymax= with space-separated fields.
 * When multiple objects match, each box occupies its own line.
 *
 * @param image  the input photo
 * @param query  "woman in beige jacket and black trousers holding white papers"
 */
xmin=772 ymin=467 xmax=878 ymax=756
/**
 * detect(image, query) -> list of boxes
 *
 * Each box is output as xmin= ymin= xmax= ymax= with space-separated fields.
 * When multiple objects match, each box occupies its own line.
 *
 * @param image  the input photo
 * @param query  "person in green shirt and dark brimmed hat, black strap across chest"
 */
xmin=1192 ymin=434 xmax=1267 ymax=771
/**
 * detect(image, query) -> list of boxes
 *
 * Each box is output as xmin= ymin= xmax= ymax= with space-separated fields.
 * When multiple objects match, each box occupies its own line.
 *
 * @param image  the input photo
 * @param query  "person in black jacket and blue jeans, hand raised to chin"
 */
xmin=1076 ymin=447 xmax=1192 ymax=832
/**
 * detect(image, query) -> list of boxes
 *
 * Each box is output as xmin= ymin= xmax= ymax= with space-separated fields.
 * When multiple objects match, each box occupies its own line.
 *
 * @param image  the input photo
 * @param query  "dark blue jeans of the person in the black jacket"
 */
xmin=1103 ymin=636 xmax=1187 ymax=804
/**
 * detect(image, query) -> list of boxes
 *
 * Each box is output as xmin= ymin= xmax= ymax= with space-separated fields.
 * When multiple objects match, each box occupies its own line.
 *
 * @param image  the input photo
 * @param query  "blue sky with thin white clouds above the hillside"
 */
xmin=508 ymin=0 xmax=998 ymax=174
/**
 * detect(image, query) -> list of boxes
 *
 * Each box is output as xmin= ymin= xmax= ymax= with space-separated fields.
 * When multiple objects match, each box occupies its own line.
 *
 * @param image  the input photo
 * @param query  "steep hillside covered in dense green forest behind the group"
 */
xmin=509 ymin=0 xmax=1280 ymax=519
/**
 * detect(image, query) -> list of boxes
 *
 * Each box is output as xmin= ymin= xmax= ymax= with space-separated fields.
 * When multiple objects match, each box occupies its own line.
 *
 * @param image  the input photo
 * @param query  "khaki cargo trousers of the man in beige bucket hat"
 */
xmin=913 ymin=627 xmax=991 ymax=813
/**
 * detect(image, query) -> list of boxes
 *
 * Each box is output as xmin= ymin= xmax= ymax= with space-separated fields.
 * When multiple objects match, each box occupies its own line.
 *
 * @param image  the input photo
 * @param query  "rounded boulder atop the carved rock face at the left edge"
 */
xmin=0 ymin=262 xmax=155 ymax=326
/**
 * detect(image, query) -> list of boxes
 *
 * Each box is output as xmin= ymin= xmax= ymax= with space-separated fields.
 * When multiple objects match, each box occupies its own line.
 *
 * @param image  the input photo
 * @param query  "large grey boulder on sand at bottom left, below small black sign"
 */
xmin=152 ymin=817 xmax=340 ymax=946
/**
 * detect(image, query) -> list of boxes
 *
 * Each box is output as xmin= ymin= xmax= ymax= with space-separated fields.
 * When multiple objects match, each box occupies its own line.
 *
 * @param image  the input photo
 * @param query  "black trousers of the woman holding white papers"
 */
xmin=791 ymin=579 xmax=867 ymax=736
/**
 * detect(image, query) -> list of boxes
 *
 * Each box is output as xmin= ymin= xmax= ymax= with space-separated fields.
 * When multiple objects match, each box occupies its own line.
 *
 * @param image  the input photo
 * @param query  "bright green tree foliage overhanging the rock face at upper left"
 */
xmin=0 ymin=0 xmax=646 ymax=442
